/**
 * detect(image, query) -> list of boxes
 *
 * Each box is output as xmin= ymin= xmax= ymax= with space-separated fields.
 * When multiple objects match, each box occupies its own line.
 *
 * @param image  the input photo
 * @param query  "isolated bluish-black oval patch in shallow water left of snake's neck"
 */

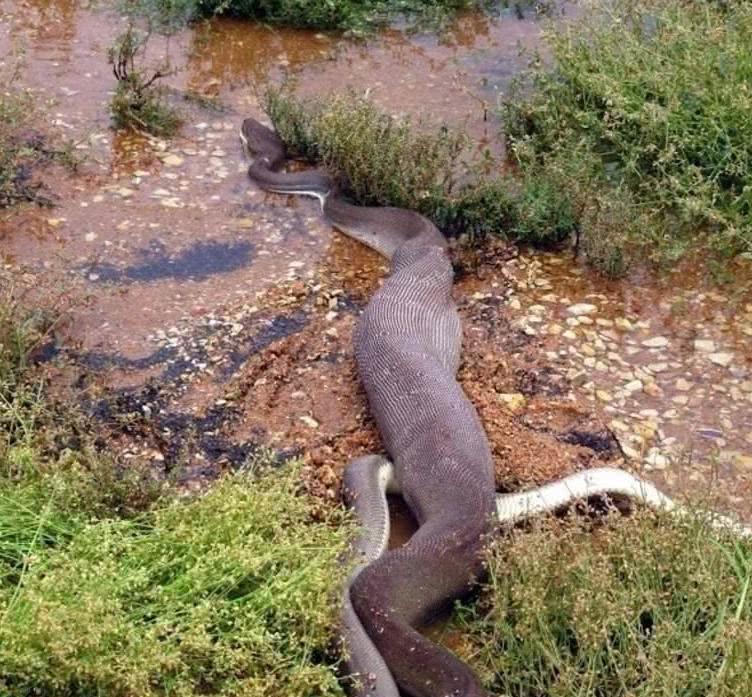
xmin=87 ymin=240 xmax=254 ymax=283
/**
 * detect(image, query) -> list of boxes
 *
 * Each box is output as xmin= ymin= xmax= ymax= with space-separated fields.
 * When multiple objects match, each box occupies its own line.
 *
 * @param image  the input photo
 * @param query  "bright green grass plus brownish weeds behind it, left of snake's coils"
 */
xmin=0 ymin=297 xmax=352 ymax=697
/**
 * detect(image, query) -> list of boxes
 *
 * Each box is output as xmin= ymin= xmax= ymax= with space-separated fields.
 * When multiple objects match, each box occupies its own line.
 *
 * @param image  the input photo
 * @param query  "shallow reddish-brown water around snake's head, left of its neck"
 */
xmin=0 ymin=0 xmax=564 ymax=357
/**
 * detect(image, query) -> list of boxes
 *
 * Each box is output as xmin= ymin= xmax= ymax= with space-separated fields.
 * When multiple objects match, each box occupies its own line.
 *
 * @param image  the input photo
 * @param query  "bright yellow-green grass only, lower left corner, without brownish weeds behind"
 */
xmin=0 ymin=462 xmax=348 ymax=697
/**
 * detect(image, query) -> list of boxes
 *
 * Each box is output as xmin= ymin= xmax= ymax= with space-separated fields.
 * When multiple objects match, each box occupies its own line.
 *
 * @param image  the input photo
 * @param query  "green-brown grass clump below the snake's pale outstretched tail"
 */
xmin=452 ymin=512 xmax=752 ymax=697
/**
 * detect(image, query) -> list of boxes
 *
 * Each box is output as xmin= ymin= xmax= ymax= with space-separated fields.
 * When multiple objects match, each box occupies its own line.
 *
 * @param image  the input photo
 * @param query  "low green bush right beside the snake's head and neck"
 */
xmin=265 ymin=90 xmax=575 ymax=244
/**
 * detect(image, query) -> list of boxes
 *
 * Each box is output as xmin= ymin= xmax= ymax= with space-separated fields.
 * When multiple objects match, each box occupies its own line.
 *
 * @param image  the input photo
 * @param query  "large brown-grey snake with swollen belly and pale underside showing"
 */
xmin=240 ymin=119 xmax=750 ymax=697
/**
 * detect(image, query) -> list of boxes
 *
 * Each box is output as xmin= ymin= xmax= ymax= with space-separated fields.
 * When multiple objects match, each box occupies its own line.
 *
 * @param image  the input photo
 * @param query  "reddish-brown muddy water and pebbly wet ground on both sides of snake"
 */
xmin=0 ymin=0 xmax=752 ymax=515
